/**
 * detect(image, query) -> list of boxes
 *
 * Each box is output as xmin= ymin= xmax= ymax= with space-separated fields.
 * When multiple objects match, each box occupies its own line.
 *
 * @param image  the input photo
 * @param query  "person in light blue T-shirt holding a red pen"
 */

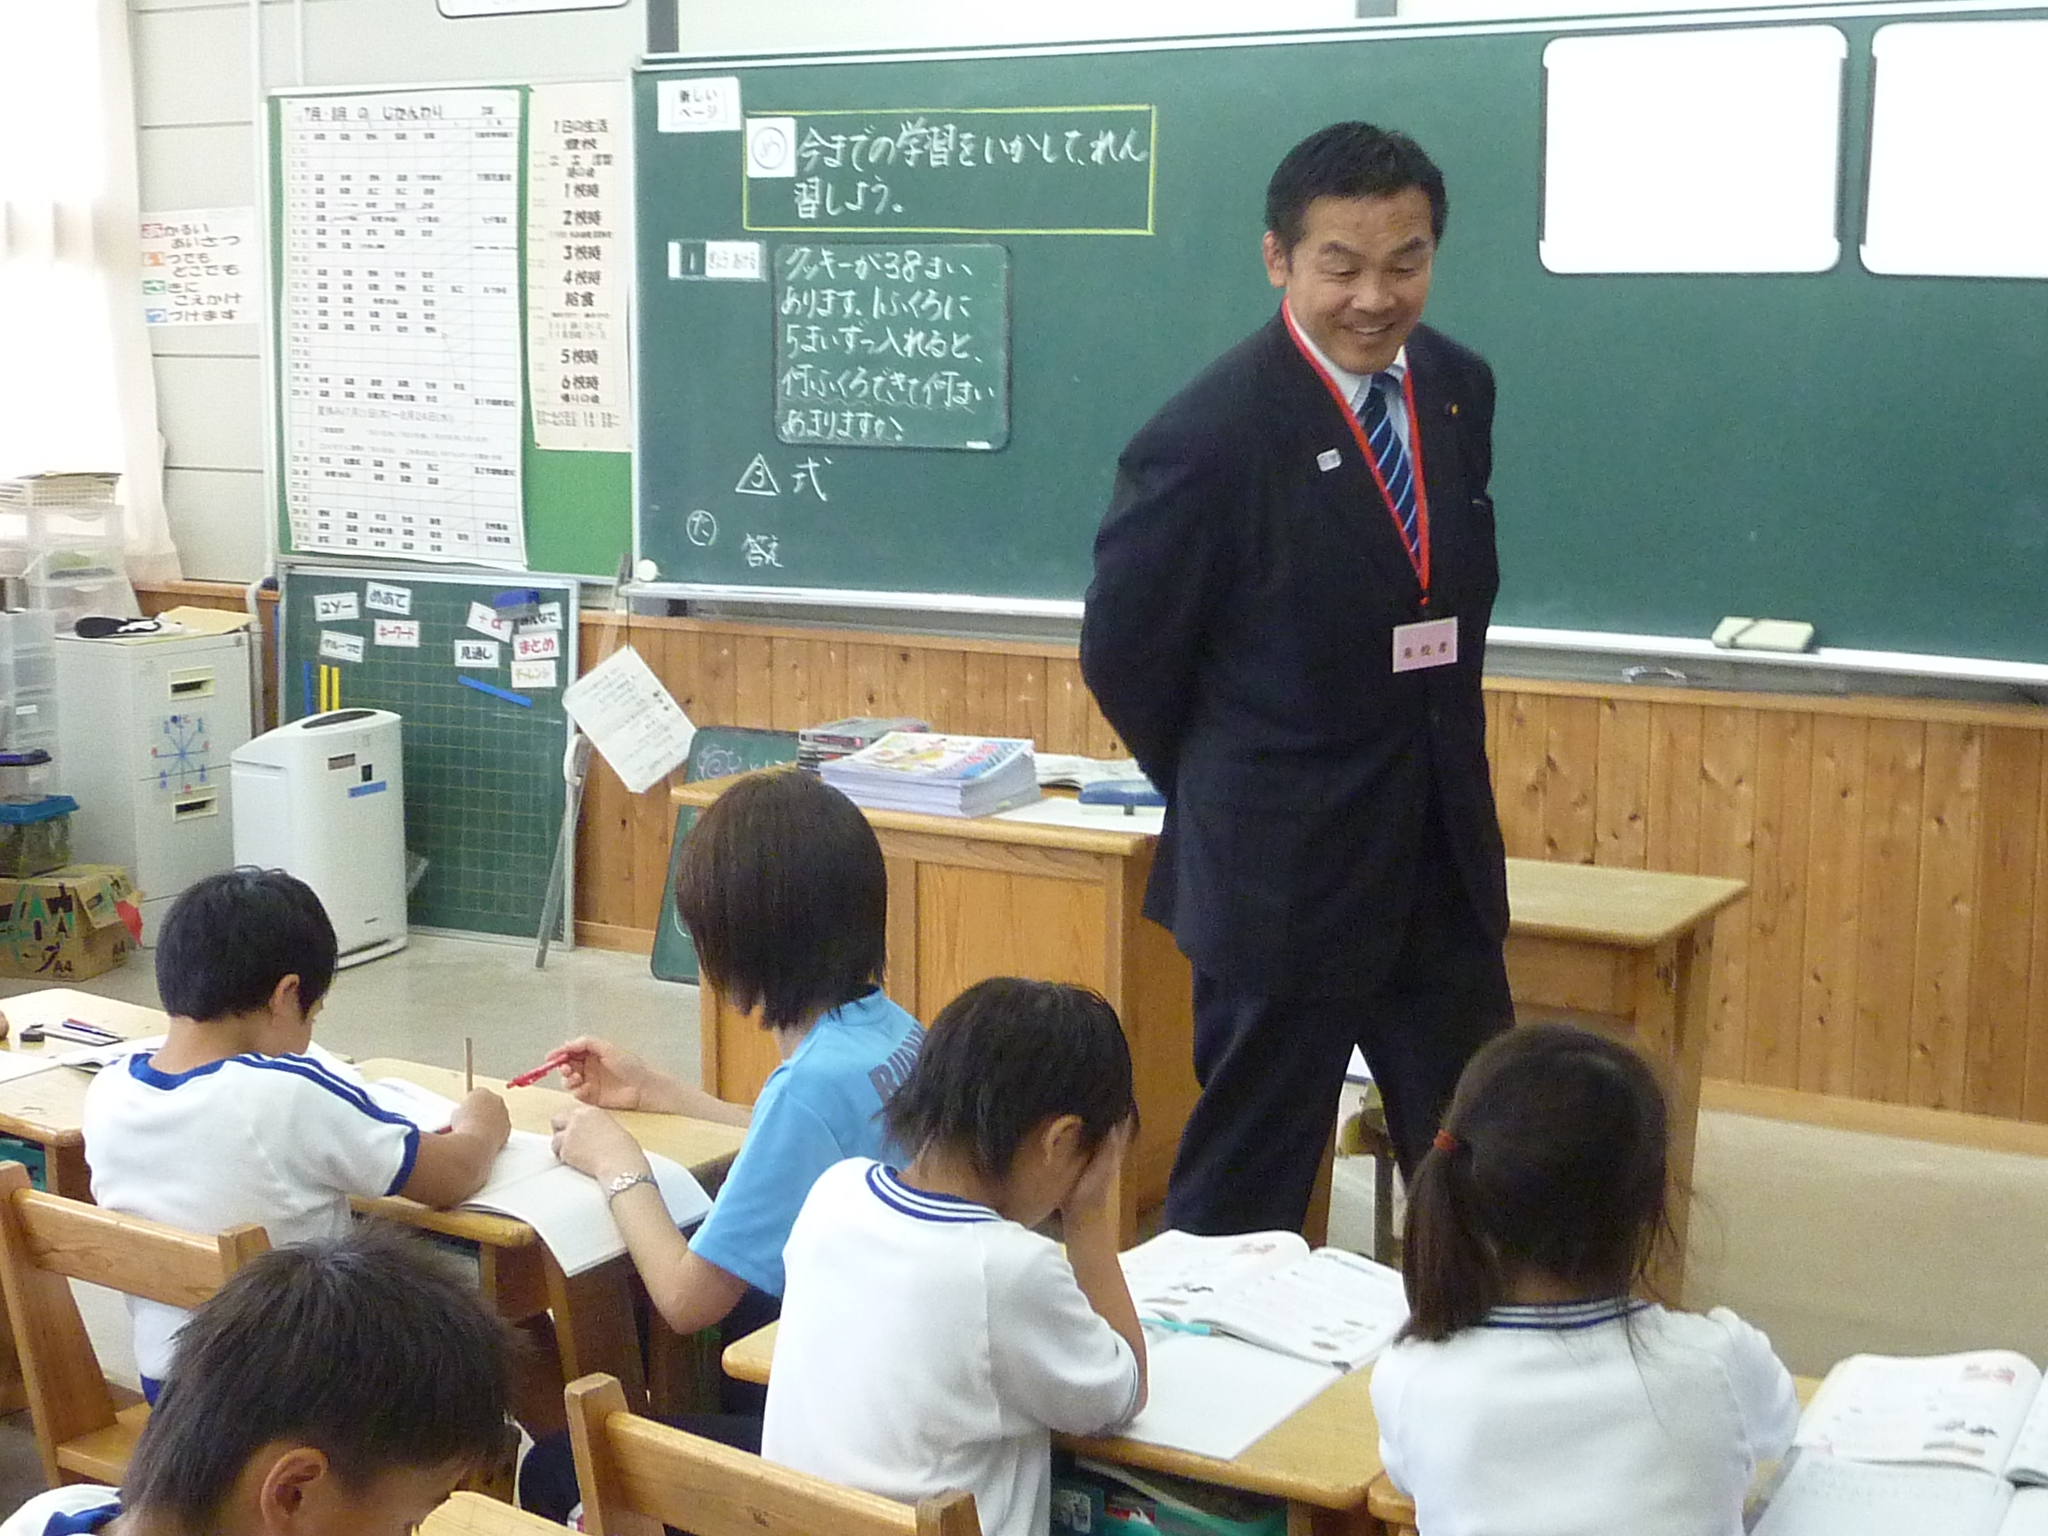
xmin=520 ymin=770 xmax=924 ymax=1520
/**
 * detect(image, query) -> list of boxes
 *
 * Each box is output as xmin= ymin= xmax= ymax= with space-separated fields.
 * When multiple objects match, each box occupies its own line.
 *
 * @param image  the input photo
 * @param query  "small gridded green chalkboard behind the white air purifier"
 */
xmin=279 ymin=565 xmax=578 ymax=938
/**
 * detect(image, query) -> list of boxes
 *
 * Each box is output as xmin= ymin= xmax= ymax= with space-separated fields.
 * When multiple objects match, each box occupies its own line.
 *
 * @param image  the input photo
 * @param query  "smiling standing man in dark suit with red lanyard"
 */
xmin=1081 ymin=123 xmax=1511 ymax=1233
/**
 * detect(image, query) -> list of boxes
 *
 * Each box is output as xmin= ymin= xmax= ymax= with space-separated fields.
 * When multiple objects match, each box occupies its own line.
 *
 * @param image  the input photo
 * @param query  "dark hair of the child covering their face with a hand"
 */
xmin=883 ymin=977 xmax=1139 ymax=1182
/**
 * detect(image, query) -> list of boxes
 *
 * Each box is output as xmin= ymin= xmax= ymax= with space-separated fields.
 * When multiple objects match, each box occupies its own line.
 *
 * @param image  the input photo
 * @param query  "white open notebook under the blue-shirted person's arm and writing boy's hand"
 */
xmin=365 ymin=1077 xmax=711 ymax=1274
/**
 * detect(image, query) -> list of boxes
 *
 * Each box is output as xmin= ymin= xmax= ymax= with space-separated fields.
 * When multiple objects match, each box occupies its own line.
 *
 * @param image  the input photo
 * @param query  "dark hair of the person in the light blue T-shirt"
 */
xmin=676 ymin=768 xmax=889 ymax=1028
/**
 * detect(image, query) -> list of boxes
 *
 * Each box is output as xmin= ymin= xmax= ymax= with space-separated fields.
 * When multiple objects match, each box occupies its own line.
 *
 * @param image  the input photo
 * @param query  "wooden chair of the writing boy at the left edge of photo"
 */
xmin=0 ymin=1163 xmax=270 ymax=1487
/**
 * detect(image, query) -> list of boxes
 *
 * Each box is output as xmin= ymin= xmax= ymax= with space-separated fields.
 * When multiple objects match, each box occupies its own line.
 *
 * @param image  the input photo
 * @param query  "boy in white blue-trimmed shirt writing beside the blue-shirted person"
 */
xmin=84 ymin=868 xmax=512 ymax=1403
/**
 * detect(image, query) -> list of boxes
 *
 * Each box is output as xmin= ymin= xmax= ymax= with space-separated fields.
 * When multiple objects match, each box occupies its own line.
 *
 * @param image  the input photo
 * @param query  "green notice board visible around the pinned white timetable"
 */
xmin=268 ymin=86 xmax=633 ymax=578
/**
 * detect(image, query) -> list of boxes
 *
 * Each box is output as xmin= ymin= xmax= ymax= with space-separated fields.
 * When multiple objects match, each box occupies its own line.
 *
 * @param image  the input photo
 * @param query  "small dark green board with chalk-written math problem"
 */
xmin=774 ymin=244 xmax=1010 ymax=449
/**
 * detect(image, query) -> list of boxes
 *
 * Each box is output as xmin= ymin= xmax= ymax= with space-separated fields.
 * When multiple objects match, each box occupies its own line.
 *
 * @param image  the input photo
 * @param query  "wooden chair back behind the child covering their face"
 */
xmin=563 ymin=1376 xmax=981 ymax=1536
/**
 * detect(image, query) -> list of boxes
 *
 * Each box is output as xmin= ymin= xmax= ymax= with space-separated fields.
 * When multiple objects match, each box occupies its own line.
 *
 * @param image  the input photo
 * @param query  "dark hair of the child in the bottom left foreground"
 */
xmin=121 ymin=1223 xmax=514 ymax=1530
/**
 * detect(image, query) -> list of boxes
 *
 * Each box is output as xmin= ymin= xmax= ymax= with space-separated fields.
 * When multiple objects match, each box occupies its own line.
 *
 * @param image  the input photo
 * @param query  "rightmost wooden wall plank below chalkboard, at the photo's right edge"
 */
xmin=1962 ymin=727 xmax=2048 ymax=1118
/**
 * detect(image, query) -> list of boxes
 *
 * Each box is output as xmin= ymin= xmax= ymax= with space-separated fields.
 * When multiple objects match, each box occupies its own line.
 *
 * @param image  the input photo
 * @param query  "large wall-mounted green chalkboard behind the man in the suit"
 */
xmin=635 ymin=6 xmax=2048 ymax=662
